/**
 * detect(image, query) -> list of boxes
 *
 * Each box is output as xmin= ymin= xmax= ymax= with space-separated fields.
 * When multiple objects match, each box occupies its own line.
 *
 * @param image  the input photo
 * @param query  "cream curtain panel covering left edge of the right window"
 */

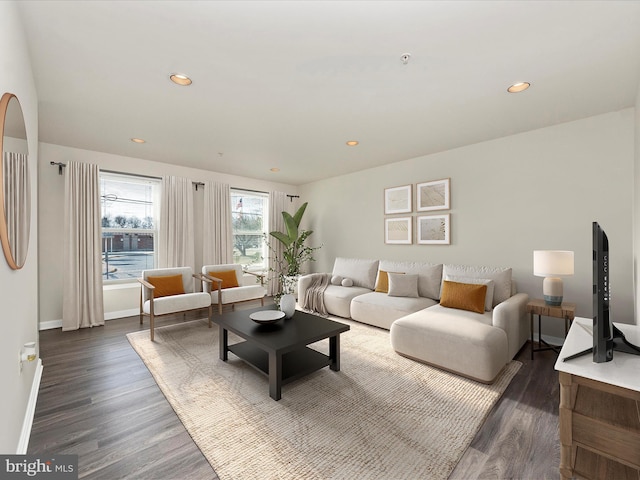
xmin=202 ymin=181 xmax=233 ymax=265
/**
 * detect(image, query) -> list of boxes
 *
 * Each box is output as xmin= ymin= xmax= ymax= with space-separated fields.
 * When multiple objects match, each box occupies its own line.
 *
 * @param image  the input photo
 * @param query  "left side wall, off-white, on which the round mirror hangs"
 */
xmin=0 ymin=2 xmax=39 ymax=454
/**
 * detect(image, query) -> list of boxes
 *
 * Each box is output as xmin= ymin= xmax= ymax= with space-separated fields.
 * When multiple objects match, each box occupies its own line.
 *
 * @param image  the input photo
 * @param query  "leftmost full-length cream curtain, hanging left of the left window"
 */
xmin=62 ymin=162 xmax=104 ymax=330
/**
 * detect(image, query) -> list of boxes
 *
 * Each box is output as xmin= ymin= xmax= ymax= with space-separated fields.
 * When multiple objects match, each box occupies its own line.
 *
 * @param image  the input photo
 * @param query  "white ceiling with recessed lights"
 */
xmin=18 ymin=0 xmax=640 ymax=184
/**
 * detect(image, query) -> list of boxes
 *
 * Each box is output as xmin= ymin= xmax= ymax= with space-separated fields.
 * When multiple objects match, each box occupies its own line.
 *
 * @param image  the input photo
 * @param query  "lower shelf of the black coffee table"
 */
xmin=228 ymin=341 xmax=332 ymax=385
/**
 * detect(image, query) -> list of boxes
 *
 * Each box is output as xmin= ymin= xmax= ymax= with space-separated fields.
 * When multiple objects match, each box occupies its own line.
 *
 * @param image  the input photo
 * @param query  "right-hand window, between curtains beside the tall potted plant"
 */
xmin=231 ymin=190 xmax=269 ymax=271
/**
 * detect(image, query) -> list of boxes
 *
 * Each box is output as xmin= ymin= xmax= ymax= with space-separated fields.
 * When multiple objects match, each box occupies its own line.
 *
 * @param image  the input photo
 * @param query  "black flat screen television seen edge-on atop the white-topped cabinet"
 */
xmin=563 ymin=222 xmax=640 ymax=363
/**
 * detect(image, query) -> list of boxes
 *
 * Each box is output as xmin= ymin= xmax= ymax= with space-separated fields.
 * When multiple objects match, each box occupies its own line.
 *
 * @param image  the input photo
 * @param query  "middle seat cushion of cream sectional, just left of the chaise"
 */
xmin=351 ymin=292 xmax=436 ymax=330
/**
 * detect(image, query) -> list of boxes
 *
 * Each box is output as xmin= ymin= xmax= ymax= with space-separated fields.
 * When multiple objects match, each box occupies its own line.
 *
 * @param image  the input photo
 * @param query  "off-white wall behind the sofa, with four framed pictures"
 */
xmin=300 ymin=109 xmax=634 ymax=337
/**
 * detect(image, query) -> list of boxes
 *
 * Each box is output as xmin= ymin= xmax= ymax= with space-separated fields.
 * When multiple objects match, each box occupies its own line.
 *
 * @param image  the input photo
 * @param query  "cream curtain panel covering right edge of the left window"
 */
xmin=158 ymin=177 xmax=196 ymax=271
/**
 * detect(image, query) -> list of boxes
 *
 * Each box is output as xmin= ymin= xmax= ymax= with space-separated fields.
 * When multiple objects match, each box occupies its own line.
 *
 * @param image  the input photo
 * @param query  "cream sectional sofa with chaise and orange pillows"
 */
xmin=298 ymin=258 xmax=529 ymax=383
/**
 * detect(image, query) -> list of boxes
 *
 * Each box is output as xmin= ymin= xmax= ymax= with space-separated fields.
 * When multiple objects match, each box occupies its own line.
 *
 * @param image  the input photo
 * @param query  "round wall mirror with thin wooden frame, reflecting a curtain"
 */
xmin=0 ymin=93 xmax=31 ymax=270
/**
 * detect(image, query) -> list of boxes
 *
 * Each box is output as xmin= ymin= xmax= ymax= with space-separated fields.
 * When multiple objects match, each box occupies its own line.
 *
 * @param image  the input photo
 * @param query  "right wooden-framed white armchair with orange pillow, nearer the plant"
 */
xmin=202 ymin=263 xmax=267 ymax=314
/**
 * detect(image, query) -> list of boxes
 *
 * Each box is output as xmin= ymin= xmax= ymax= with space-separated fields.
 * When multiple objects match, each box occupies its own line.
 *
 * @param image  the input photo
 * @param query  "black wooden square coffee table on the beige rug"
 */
xmin=213 ymin=306 xmax=350 ymax=400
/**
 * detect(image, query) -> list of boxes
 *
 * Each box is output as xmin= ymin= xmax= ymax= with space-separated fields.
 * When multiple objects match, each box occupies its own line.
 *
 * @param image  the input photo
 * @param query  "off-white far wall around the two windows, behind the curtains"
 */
xmin=39 ymin=143 xmax=297 ymax=328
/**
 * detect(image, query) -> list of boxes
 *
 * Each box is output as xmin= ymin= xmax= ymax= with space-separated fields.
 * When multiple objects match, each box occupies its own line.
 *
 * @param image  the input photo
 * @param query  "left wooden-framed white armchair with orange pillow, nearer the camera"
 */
xmin=138 ymin=267 xmax=213 ymax=342
